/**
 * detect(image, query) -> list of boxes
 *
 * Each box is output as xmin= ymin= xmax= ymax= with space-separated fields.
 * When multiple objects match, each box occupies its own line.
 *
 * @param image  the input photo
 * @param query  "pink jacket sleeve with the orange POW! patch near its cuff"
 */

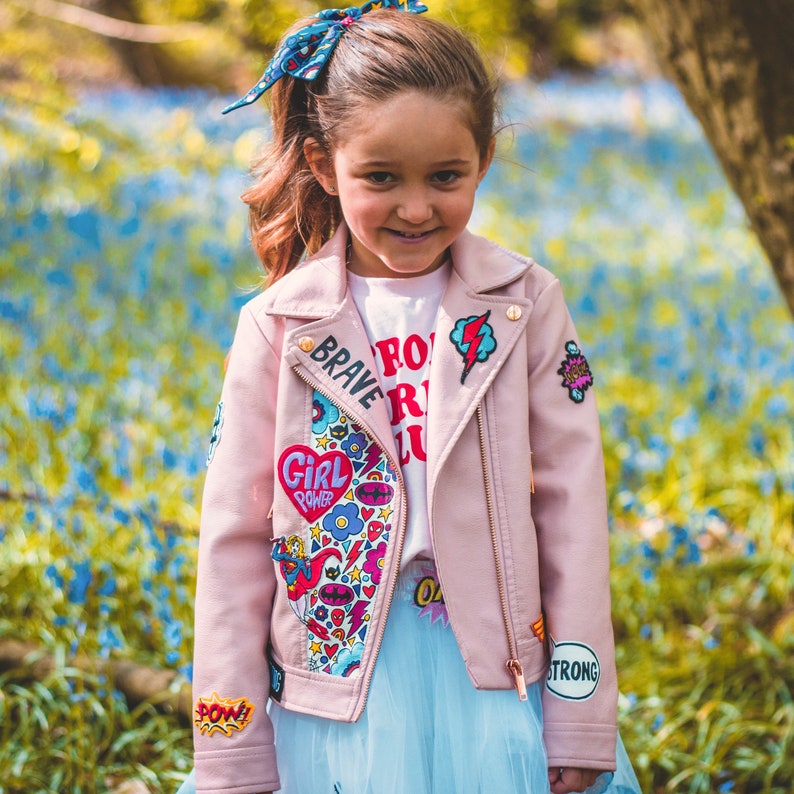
xmin=193 ymin=304 xmax=279 ymax=794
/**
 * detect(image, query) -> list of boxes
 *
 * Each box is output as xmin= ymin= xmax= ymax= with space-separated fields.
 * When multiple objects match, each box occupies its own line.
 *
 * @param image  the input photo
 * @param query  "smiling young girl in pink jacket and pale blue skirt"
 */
xmin=179 ymin=0 xmax=638 ymax=794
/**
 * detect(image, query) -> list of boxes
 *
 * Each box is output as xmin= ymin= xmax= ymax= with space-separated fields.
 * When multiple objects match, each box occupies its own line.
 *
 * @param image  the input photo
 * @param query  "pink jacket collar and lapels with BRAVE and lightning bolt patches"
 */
xmin=267 ymin=220 xmax=533 ymax=486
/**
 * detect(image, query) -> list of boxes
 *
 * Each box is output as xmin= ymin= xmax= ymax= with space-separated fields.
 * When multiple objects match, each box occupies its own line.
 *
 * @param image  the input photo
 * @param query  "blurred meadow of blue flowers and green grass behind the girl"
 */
xmin=0 ymin=77 xmax=794 ymax=793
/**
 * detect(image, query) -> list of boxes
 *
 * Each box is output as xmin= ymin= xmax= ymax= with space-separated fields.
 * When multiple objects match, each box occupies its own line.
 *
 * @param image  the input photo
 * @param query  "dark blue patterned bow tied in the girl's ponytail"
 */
xmin=222 ymin=0 xmax=427 ymax=113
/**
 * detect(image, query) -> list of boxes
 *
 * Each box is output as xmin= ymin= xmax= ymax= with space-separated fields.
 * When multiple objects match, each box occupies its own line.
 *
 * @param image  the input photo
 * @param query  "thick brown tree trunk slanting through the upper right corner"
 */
xmin=630 ymin=0 xmax=794 ymax=316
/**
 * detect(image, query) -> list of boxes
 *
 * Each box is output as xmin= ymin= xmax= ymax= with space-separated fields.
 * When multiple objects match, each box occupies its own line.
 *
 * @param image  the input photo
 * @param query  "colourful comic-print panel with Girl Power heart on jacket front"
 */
xmin=272 ymin=392 xmax=399 ymax=676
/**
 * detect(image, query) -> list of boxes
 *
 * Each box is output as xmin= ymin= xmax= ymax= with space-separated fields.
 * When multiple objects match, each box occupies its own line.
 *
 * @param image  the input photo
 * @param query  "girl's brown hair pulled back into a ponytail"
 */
xmin=242 ymin=9 xmax=496 ymax=283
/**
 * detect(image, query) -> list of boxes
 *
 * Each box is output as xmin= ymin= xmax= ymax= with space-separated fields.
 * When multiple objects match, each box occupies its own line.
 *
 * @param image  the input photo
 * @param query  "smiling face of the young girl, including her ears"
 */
xmin=306 ymin=90 xmax=493 ymax=278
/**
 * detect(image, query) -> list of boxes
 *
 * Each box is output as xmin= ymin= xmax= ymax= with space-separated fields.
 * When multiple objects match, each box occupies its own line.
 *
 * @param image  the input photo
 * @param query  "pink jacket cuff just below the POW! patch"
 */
xmin=193 ymin=744 xmax=281 ymax=794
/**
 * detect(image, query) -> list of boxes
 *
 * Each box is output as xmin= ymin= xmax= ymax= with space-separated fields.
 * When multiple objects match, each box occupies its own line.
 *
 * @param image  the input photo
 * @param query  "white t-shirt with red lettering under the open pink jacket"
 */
xmin=348 ymin=262 xmax=452 ymax=565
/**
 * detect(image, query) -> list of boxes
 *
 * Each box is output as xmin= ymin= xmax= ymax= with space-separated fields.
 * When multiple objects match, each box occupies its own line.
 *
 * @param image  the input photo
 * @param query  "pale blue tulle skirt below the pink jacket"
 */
xmin=179 ymin=562 xmax=640 ymax=794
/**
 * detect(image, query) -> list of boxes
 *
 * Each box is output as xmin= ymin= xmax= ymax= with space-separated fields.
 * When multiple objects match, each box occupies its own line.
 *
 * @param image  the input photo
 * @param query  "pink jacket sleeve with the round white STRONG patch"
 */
xmin=529 ymin=279 xmax=618 ymax=770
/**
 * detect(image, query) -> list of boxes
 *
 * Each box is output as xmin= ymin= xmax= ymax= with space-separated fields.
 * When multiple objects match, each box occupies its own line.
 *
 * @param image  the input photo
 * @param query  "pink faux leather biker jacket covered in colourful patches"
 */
xmin=193 ymin=226 xmax=617 ymax=793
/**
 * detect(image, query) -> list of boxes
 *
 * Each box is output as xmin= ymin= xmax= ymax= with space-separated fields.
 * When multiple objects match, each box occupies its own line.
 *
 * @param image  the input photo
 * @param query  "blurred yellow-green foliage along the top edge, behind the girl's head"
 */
xmin=0 ymin=0 xmax=647 ymax=94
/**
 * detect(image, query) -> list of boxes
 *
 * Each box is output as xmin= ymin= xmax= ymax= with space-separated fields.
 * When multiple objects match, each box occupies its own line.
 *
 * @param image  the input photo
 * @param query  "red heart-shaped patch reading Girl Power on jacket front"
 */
xmin=278 ymin=444 xmax=353 ymax=522
